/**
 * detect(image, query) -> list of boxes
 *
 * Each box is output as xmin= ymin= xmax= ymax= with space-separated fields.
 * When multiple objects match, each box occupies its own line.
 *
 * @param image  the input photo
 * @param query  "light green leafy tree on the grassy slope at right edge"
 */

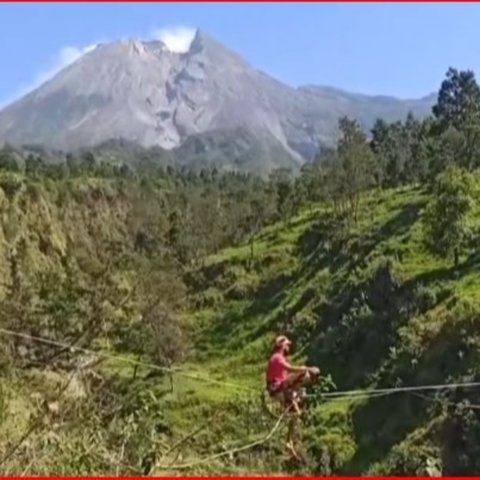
xmin=424 ymin=165 xmax=473 ymax=267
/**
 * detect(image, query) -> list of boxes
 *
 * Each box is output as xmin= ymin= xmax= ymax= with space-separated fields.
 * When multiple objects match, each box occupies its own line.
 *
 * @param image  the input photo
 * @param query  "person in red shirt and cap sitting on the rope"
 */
xmin=266 ymin=335 xmax=320 ymax=413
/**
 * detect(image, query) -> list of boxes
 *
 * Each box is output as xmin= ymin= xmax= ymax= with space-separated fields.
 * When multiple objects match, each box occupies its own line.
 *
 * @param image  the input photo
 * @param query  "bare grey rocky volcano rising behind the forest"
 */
xmin=0 ymin=31 xmax=433 ymax=169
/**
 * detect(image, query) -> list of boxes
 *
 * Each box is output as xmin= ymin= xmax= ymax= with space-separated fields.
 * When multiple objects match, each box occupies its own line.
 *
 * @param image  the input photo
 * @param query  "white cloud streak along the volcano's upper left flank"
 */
xmin=0 ymin=44 xmax=98 ymax=108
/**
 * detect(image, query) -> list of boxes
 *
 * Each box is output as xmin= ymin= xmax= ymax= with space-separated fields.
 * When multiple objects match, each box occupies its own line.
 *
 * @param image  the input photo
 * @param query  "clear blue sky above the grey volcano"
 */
xmin=0 ymin=3 xmax=480 ymax=105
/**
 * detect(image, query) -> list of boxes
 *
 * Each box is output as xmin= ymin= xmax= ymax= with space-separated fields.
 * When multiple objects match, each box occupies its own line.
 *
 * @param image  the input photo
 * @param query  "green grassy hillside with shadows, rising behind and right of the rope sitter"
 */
xmin=179 ymin=182 xmax=480 ymax=475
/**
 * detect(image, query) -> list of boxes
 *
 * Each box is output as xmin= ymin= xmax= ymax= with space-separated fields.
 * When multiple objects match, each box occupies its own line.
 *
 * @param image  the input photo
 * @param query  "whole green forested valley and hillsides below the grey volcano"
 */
xmin=0 ymin=65 xmax=480 ymax=476
